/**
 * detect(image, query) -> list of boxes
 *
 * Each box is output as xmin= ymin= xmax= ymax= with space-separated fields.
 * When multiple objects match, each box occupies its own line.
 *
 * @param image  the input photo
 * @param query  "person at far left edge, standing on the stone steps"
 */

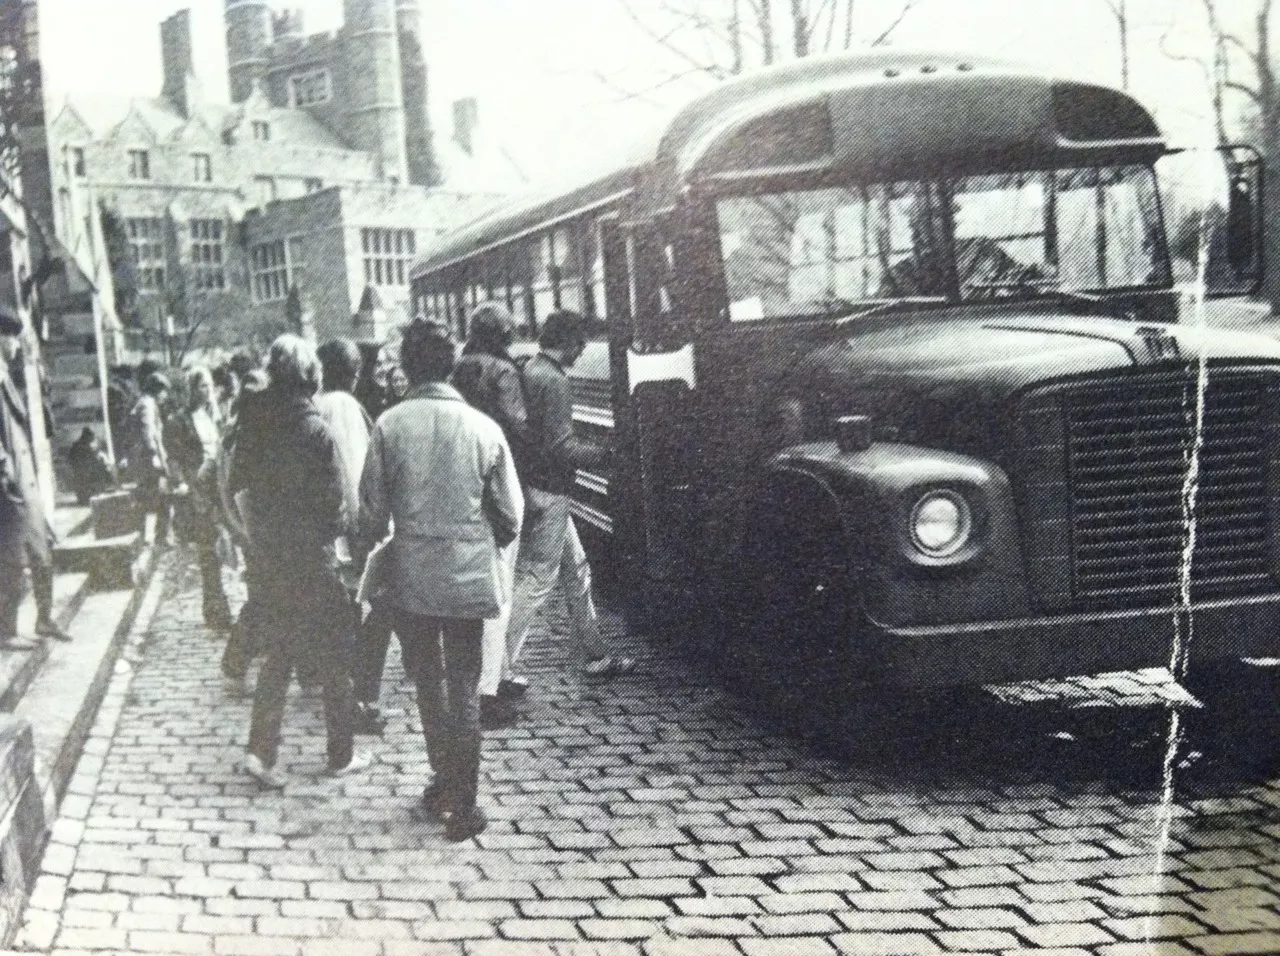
xmin=0 ymin=310 xmax=70 ymax=650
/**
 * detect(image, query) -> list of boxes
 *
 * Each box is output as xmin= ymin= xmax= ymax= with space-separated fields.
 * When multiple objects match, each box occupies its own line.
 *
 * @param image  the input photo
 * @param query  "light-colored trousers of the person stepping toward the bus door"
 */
xmin=507 ymin=488 xmax=609 ymax=667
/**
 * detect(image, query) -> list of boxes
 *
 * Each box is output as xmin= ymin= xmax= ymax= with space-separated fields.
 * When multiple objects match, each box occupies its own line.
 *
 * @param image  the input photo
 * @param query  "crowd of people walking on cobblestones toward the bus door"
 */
xmin=80 ymin=302 xmax=635 ymax=841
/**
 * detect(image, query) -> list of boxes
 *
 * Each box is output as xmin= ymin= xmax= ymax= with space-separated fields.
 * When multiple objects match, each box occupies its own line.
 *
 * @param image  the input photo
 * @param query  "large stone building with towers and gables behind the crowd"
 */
xmin=41 ymin=0 xmax=522 ymax=455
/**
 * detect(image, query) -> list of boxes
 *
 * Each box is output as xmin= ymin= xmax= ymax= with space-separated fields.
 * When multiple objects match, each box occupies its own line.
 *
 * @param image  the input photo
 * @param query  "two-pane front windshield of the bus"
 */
xmin=717 ymin=165 xmax=1170 ymax=321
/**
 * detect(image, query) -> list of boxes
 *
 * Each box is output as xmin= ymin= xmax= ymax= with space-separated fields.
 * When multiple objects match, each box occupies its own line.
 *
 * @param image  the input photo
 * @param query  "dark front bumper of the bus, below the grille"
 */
xmin=858 ymin=594 xmax=1280 ymax=687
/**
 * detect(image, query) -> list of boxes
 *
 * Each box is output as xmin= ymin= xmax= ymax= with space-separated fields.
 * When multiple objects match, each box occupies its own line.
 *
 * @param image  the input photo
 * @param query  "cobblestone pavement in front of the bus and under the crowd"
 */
xmin=18 ymin=559 xmax=1280 ymax=956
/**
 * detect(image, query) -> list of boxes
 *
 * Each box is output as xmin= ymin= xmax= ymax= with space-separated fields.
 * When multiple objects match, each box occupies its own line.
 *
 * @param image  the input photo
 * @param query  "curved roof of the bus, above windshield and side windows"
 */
xmin=412 ymin=50 xmax=1165 ymax=279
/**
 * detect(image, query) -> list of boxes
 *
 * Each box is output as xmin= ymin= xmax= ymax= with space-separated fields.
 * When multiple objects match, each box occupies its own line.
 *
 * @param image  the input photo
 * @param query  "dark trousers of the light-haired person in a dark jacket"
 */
xmin=248 ymin=622 xmax=355 ymax=769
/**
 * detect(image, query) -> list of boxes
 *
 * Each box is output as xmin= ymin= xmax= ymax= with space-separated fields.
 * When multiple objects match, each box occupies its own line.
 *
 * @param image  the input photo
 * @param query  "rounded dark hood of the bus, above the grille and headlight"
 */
xmin=783 ymin=310 xmax=1280 ymax=461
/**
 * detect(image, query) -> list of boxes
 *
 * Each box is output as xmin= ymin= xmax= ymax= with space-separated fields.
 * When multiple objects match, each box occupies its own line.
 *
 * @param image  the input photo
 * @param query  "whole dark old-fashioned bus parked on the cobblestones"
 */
xmin=412 ymin=51 xmax=1280 ymax=689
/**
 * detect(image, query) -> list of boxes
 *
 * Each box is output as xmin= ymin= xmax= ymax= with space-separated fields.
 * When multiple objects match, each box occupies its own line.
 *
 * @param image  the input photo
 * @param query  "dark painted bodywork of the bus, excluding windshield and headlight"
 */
xmin=413 ymin=52 xmax=1280 ymax=687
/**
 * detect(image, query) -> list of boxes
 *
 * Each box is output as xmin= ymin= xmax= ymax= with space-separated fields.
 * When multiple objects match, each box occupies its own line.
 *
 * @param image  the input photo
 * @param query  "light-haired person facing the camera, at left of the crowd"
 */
xmin=169 ymin=365 xmax=232 ymax=632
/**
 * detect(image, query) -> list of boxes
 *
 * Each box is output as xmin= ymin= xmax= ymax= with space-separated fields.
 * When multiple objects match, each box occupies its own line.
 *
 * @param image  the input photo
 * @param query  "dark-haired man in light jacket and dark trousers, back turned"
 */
xmin=360 ymin=321 xmax=524 ymax=842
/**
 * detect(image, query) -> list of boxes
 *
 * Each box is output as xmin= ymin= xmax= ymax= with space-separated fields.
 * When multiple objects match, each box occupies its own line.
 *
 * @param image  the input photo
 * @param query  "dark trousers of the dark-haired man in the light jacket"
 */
xmin=394 ymin=609 xmax=484 ymax=813
